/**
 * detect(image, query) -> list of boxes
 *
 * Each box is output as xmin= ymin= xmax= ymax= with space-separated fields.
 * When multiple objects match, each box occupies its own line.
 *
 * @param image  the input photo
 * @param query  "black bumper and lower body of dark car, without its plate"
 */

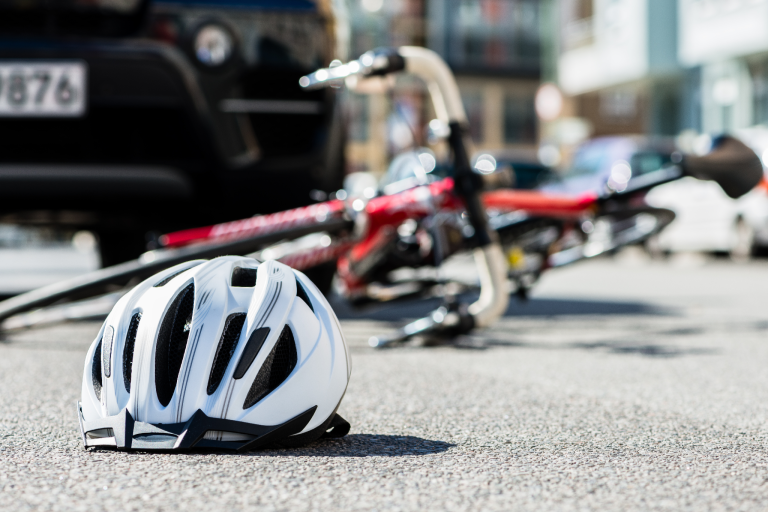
xmin=0 ymin=39 xmax=340 ymax=226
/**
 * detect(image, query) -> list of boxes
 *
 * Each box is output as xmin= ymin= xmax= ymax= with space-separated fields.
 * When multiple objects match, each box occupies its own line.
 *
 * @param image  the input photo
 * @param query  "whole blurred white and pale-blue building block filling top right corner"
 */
xmin=551 ymin=0 xmax=768 ymax=150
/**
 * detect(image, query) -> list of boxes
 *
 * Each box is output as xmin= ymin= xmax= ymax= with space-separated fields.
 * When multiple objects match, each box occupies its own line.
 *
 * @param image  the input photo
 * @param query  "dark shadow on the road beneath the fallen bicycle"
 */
xmin=331 ymin=295 xmax=674 ymax=322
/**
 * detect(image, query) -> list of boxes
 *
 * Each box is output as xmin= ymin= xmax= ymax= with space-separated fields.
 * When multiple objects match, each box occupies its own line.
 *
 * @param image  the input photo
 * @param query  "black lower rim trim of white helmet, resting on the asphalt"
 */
xmin=77 ymin=402 xmax=332 ymax=452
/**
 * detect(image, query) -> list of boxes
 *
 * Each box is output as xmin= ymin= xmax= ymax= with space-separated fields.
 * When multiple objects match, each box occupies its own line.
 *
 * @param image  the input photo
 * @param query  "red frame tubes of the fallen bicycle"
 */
xmin=160 ymin=178 xmax=598 ymax=291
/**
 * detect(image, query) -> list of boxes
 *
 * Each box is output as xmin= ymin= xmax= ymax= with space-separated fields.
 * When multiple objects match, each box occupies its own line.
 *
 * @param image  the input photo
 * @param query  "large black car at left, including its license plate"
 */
xmin=0 ymin=0 xmax=347 ymax=265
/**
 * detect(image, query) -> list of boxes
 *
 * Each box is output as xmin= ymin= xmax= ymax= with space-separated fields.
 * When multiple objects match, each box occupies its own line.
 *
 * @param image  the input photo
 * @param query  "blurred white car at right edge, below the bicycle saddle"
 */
xmin=646 ymin=178 xmax=768 ymax=259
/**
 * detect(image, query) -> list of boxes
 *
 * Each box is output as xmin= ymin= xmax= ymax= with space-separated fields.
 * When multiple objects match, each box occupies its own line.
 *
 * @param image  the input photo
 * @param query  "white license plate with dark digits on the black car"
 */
xmin=0 ymin=61 xmax=87 ymax=117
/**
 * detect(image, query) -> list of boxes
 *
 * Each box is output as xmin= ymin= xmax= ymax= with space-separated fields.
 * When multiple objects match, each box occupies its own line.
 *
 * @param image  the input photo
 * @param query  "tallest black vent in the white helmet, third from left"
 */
xmin=155 ymin=284 xmax=195 ymax=406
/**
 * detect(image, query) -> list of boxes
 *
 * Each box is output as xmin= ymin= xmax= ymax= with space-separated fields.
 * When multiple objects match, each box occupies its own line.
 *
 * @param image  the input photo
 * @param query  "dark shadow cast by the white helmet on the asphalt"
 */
xmin=252 ymin=434 xmax=456 ymax=457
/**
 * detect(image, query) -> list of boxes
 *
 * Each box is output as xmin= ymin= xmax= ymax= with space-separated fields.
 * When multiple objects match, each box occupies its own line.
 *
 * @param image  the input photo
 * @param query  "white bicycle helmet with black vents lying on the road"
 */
xmin=78 ymin=256 xmax=351 ymax=450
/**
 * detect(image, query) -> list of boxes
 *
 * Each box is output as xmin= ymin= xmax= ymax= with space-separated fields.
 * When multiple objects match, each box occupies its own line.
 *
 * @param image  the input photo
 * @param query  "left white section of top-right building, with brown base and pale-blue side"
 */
xmin=557 ymin=0 xmax=687 ymax=140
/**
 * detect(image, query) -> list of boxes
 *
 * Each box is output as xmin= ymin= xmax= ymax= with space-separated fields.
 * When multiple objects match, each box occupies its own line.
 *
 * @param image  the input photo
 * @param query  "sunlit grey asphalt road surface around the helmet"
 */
xmin=0 ymin=254 xmax=768 ymax=512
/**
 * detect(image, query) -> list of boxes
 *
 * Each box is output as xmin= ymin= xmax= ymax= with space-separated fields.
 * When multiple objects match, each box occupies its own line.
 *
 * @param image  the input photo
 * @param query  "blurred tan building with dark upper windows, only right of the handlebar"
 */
xmin=427 ymin=0 xmax=541 ymax=149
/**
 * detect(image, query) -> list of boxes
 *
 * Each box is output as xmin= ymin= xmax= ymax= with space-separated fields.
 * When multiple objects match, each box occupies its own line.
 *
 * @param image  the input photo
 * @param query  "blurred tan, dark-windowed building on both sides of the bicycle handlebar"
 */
xmin=347 ymin=0 xmax=541 ymax=172
